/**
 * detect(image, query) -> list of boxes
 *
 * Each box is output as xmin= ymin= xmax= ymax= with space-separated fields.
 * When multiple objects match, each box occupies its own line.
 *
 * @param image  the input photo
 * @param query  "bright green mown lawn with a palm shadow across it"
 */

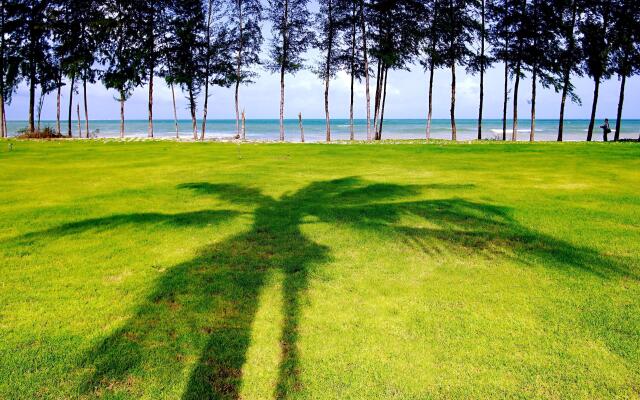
xmin=0 ymin=141 xmax=640 ymax=399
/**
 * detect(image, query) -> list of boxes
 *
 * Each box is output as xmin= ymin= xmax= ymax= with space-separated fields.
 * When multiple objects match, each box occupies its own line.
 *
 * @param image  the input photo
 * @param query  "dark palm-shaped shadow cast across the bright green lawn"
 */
xmin=12 ymin=178 xmax=637 ymax=399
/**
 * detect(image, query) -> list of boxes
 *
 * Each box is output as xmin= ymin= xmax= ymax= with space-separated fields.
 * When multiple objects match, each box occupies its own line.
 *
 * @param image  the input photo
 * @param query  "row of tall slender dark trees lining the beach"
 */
xmin=0 ymin=0 xmax=640 ymax=141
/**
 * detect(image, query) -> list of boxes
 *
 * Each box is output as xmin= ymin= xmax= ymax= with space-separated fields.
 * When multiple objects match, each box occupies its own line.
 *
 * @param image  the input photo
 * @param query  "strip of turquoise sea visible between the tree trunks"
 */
xmin=7 ymin=119 xmax=640 ymax=142
